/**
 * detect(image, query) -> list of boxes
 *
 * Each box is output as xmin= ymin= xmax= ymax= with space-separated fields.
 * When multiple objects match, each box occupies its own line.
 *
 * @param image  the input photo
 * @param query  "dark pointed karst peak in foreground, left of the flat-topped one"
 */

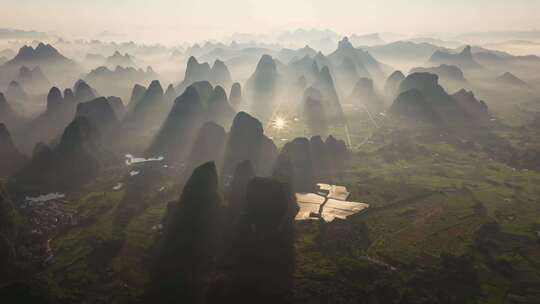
xmin=147 ymin=162 xmax=220 ymax=303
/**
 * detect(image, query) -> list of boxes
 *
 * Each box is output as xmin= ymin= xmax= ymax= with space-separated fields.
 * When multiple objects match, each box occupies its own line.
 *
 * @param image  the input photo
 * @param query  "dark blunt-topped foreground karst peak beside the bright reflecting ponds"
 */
xmin=222 ymin=177 xmax=298 ymax=303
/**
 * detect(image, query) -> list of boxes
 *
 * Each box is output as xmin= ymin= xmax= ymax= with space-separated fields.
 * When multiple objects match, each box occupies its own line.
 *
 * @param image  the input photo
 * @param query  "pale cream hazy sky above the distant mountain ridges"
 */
xmin=0 ymin=0 xmax=540 ymax=42
